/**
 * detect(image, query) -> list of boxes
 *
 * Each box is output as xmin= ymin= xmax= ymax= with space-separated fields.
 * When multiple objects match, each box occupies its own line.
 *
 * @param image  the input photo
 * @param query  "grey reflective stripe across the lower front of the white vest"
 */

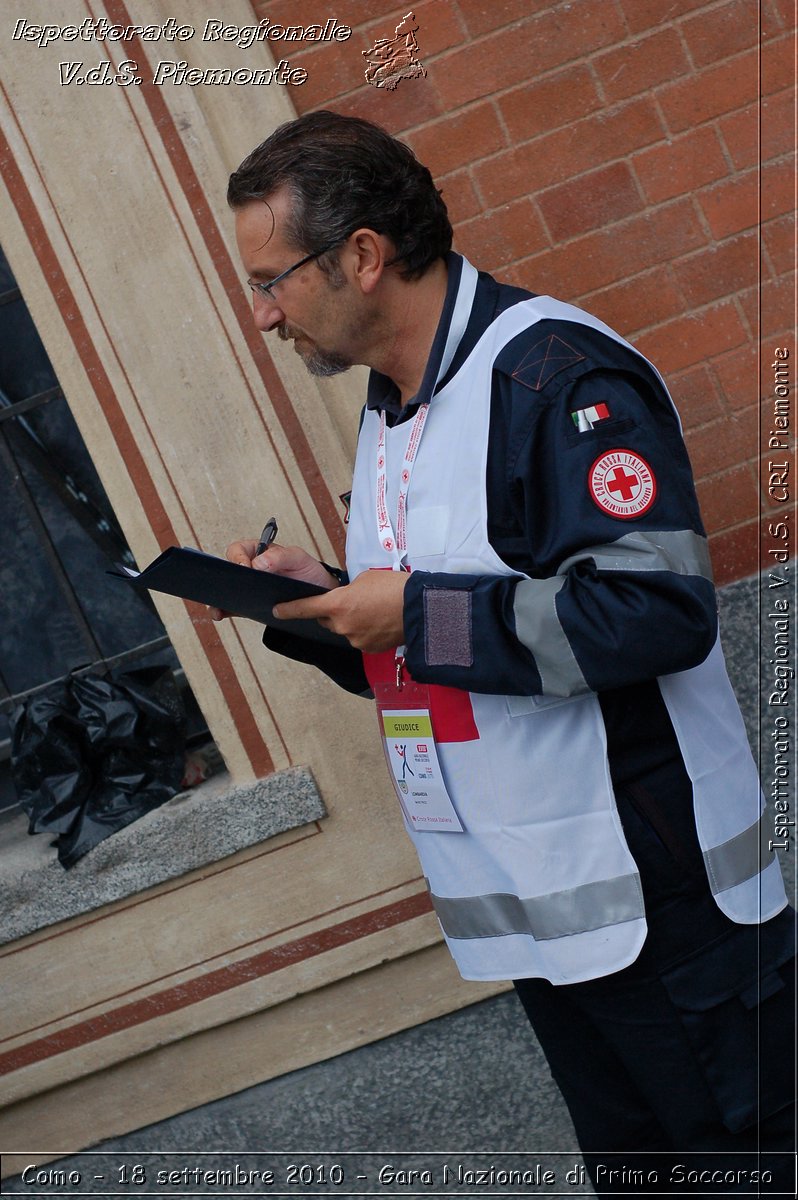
xmin=430 ymin=875 xmax=644 ymax=942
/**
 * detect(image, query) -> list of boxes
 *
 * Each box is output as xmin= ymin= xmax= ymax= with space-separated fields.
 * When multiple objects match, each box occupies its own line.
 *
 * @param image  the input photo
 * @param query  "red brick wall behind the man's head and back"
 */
xmin=254 ymin=0 xmax=794 ymax=583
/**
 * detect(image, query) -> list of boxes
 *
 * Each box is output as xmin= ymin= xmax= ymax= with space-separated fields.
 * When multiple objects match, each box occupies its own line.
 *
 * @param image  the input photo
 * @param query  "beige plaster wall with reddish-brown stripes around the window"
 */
xmin=0 ymin=0 xmax=504 ymax=1150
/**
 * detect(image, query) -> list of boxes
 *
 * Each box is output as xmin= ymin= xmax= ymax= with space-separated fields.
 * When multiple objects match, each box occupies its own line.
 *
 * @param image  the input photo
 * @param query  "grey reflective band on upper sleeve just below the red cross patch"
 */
xmin=557 ymin=529 xmax=712 ymax=581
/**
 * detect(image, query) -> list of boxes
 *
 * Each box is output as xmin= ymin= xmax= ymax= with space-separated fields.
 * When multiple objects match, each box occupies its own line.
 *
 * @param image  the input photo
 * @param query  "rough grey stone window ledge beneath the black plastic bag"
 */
xmin=0 ymin=767 xmax=326 ymax=944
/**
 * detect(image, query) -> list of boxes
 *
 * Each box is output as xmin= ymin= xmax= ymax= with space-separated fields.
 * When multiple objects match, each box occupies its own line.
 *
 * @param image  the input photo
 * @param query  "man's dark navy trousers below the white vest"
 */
xmin=515 ymin=777 xmax=796 ymax=1196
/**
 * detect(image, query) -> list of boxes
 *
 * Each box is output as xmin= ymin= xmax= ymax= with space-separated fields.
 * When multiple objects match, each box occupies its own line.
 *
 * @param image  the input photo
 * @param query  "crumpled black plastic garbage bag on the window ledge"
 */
xmin=11 ymin=667 xmax=186 ymax=868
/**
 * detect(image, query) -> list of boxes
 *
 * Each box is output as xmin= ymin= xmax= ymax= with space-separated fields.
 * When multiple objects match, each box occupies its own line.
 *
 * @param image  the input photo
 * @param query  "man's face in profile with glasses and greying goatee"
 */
xmin=235 ymin=188 xmax=358 ymax=376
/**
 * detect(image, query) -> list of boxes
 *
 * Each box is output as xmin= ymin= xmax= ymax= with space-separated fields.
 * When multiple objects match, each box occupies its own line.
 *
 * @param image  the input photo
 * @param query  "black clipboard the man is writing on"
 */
xmin=108 ymin=546 xmax=349 ymax=646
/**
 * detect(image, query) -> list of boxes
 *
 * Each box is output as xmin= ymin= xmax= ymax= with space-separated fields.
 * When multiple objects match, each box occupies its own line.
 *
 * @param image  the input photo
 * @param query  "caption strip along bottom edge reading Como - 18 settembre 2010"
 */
xmin=2 ymin=1151 xmax=794 ymax=1200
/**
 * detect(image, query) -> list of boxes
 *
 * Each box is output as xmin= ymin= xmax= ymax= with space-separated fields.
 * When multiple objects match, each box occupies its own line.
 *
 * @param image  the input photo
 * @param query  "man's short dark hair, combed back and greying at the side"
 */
xmin=227 ymin=109 xmax=452 ymax=278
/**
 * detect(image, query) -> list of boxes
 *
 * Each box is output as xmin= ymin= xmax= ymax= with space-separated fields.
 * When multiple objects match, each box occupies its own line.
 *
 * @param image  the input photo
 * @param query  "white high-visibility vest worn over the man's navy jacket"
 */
xmin=347 ymin=260 xmax=786 ymax=983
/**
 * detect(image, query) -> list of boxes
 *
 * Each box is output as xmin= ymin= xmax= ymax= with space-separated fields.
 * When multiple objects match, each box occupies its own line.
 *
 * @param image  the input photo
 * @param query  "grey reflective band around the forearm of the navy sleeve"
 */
xmin=512 ymin=576 xmax=590 ymax=696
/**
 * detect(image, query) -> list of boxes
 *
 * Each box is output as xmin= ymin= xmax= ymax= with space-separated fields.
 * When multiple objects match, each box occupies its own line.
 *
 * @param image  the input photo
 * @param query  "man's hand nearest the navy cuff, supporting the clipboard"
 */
xmin=274 ymin=570 xmax=409 ymax=654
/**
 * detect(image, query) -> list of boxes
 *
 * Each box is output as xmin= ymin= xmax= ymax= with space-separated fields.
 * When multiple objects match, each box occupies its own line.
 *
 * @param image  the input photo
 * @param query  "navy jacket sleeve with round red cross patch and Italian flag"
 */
xmin=404 ymin=352 xmax=716 ymax=696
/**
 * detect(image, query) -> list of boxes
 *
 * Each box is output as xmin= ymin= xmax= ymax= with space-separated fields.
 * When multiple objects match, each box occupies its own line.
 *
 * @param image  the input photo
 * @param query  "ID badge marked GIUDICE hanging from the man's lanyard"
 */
xmin=374 ymin=679 xmax=463 ymax=833
